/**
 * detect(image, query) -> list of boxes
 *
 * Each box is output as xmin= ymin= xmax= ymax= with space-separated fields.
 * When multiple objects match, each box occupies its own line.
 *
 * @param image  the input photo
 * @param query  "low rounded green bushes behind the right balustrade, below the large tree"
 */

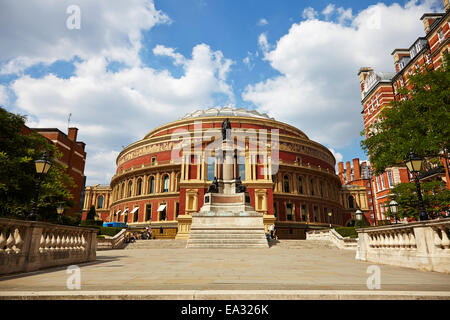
xmin=386 ymin=181 xmax=450 ymax=220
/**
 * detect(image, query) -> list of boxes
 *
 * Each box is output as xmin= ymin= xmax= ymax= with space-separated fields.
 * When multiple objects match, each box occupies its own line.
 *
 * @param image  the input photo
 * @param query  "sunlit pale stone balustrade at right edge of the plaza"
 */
xmin=357 ymin=218 xmax=450 ymax=273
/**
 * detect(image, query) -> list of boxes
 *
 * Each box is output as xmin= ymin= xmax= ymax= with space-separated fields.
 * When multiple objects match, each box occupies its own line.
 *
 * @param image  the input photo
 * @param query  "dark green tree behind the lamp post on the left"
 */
xmin=0 ymin=107 xmax=74 ymax=222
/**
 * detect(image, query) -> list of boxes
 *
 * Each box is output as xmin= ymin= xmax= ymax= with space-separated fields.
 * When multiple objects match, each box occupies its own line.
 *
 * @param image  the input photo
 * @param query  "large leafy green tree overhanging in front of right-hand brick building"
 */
xmin=361 ymin=54 xmax=450 ymax=174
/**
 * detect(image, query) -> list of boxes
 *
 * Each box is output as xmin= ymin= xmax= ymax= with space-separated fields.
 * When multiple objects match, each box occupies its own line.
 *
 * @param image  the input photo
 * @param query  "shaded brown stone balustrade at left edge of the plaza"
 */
xmin=0 ymin=218 xmax=97 ymax=275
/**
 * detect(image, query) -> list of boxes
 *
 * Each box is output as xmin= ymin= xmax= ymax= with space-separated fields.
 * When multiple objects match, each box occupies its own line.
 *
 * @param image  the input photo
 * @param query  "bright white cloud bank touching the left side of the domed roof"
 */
xmin=10 ymin=44 xmax=234 ymax=184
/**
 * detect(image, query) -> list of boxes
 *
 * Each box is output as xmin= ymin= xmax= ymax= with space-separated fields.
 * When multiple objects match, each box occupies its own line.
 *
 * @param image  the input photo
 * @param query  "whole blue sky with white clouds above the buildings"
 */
xmin=0 ymin=0 xmax=443 ymax=184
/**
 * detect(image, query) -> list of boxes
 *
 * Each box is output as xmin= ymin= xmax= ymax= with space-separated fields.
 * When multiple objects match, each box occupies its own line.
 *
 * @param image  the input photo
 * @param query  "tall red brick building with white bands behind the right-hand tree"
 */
xmin=358 ymin=0 xmax=450 ymax=220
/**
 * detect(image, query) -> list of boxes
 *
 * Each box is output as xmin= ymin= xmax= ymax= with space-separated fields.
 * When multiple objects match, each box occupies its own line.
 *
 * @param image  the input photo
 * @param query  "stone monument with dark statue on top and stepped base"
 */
xmin=187 ymin=119 xmax=269 ymax=248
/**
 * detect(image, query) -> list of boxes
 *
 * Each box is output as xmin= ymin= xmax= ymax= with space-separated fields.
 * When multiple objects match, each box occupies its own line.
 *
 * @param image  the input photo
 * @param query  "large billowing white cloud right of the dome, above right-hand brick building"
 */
xmin=242 ymin=1 xmax=442 ymax=148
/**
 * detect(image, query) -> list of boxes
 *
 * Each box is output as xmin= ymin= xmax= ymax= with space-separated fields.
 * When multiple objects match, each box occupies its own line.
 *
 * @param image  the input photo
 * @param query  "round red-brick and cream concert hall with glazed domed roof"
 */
xmin=85 ymin=107 xmax=354 ymax=239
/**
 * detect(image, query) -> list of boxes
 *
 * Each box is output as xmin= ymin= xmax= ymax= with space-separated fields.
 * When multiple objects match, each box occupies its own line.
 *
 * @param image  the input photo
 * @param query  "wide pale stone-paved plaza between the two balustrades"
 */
xmin=0 ymin=240 xmax=450 ymax=298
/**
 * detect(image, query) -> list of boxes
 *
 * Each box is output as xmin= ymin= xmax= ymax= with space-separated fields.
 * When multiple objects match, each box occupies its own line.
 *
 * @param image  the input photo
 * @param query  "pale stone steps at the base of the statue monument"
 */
xmin=187 ymin=225 xmax=269 ymax=249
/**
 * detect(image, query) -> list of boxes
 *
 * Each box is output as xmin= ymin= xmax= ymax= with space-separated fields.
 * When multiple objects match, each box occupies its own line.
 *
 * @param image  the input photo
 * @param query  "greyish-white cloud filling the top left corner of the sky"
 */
xmin=0 ymin=0 xmax=170 ymax=74
